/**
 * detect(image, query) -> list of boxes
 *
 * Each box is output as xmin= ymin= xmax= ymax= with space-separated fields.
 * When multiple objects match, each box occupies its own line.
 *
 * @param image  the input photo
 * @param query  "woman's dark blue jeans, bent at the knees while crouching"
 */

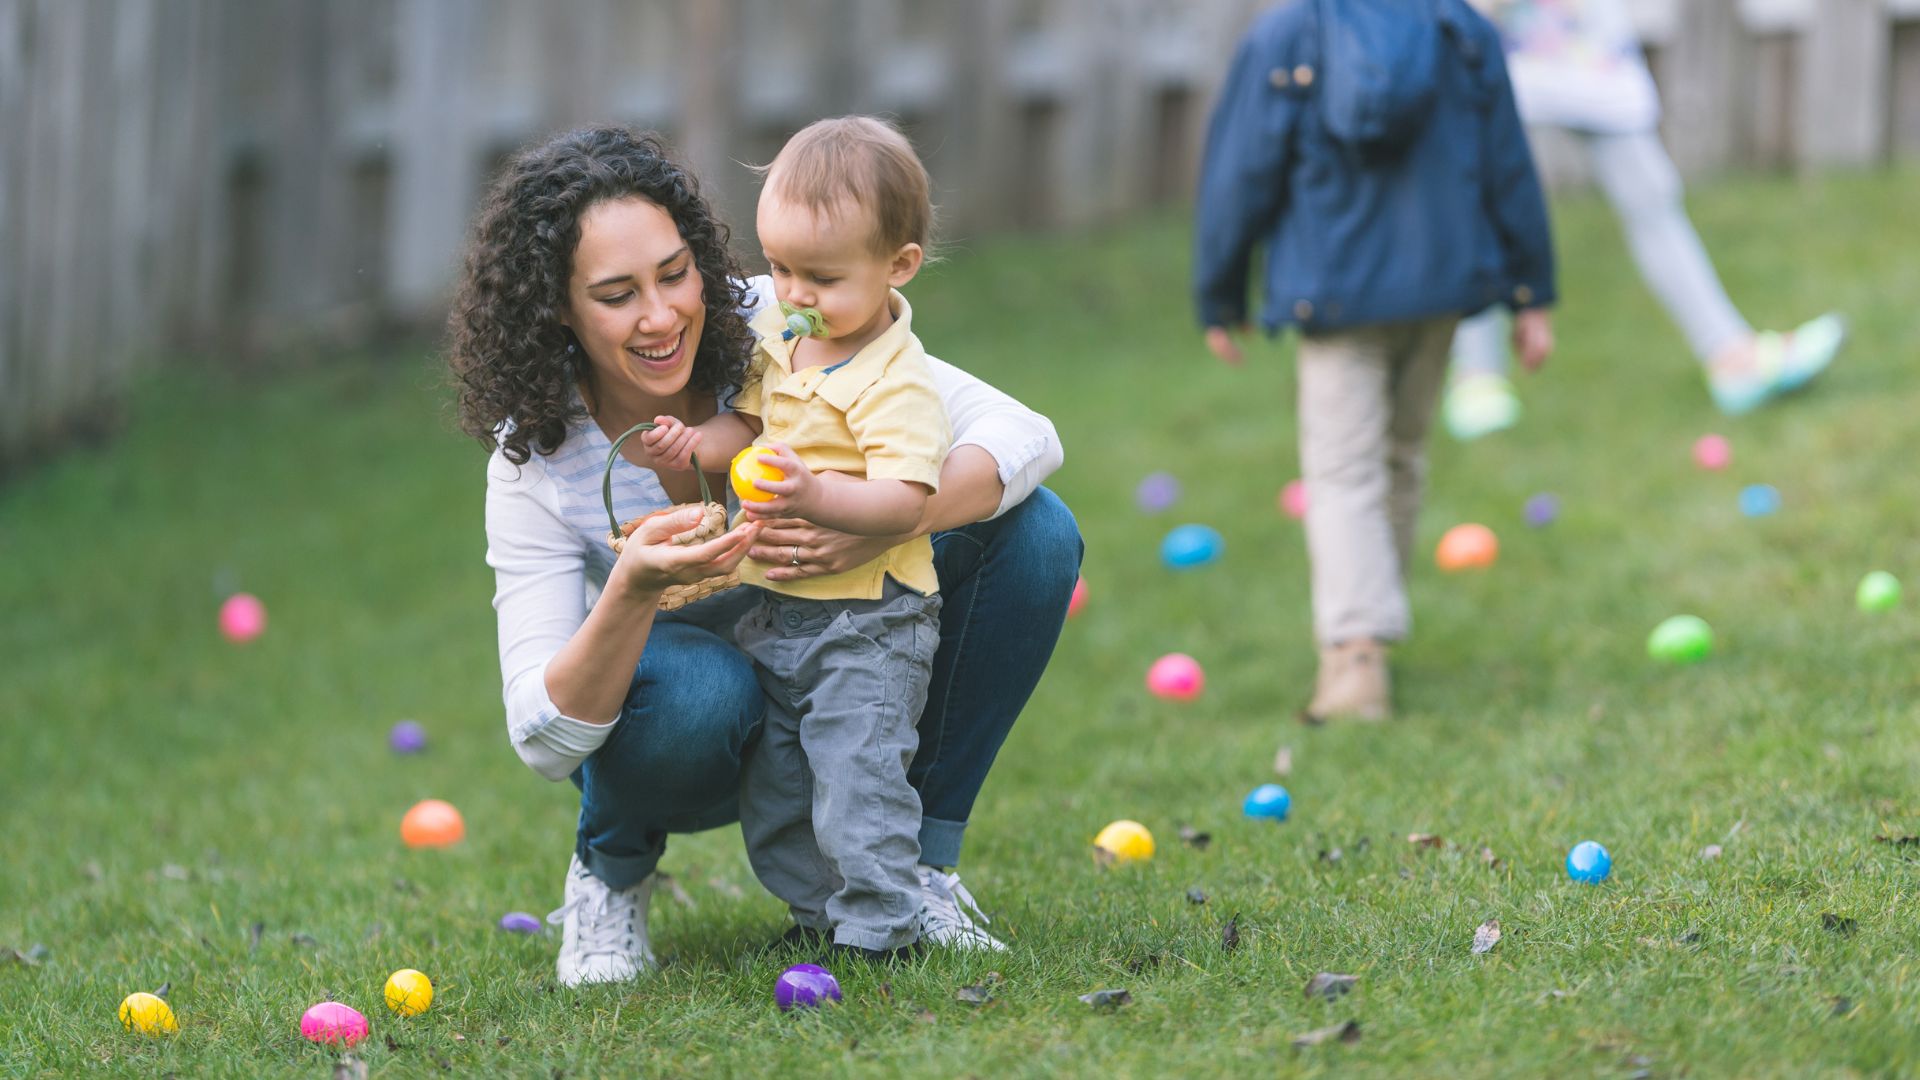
xmin=572 ymin=488 xmax=1081 ymax=888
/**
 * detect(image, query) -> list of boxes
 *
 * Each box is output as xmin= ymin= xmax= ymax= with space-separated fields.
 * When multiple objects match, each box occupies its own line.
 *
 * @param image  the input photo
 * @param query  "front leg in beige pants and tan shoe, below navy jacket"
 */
xmin=1296 ymin=327 xmax=1409 ymax=723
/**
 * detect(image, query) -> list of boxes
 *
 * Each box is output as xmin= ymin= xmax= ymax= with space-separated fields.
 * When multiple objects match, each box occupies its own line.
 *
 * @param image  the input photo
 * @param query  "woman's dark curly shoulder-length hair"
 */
xmin=447 ymin=127 xmax=753 ymax=465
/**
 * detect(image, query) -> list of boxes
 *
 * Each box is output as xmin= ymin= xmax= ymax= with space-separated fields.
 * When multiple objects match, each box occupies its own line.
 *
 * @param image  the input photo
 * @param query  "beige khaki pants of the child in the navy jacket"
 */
xmin=1298 ymin=315 xmax=1459 ymax=646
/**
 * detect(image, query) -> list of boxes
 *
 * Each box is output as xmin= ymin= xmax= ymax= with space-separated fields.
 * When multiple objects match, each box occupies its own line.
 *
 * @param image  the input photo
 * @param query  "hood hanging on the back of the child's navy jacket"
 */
xmin=1315 ymin=0 xmax=1444 ymax=150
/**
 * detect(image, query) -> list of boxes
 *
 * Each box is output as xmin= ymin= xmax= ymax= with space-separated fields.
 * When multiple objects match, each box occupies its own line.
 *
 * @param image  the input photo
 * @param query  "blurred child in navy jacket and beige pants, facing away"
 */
xmin=1194 ymin=0 xmax=1555 ymax=723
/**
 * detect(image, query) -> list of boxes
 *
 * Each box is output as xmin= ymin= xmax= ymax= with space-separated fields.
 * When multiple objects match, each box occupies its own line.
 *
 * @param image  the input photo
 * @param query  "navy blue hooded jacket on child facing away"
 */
xmin=1194 ymin=0 xmax=1555 ymax=332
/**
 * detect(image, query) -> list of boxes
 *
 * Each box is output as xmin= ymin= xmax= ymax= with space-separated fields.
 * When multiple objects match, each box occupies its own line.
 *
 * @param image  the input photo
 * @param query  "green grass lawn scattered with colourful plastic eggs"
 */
xmin=0 ymin=171 xmax=1920 ymax=1076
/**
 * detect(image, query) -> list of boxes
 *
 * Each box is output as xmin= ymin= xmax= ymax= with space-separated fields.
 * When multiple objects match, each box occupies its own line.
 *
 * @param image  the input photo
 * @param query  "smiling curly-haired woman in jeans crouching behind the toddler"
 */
xmin=449 ymin=127 xmax=1081 ymax=986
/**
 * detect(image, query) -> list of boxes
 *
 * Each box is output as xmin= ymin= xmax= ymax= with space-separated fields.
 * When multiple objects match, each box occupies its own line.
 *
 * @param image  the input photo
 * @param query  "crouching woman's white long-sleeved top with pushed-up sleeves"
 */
xmin=486 ymin=277 xmax=1062 ymax=780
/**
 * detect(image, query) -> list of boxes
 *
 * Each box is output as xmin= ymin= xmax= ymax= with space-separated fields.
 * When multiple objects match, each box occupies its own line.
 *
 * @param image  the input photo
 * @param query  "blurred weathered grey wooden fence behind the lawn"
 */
xmin=0 ymin=0 xmax=1920 ymax=467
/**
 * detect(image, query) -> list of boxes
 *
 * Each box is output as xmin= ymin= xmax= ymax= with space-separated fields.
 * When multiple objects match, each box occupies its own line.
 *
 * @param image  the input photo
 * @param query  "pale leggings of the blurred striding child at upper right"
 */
xmin=1453 ymin=131 xmax=1753 ymax=375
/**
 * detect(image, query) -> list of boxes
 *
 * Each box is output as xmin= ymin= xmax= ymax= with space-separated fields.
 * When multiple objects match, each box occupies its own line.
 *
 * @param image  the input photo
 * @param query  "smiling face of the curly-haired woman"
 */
xmin=563 ymin=198 xmax=707 ymax=398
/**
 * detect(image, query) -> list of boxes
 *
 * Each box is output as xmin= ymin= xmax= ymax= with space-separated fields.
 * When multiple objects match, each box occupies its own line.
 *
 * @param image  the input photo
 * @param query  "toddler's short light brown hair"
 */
xmin=760 ymin=115 xmax=933 ymax=259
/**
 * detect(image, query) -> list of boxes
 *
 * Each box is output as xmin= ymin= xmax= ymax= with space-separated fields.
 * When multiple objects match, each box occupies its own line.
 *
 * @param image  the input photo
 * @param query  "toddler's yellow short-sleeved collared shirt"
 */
xmin=733 ymin=290 xmax=952 ymax=600
